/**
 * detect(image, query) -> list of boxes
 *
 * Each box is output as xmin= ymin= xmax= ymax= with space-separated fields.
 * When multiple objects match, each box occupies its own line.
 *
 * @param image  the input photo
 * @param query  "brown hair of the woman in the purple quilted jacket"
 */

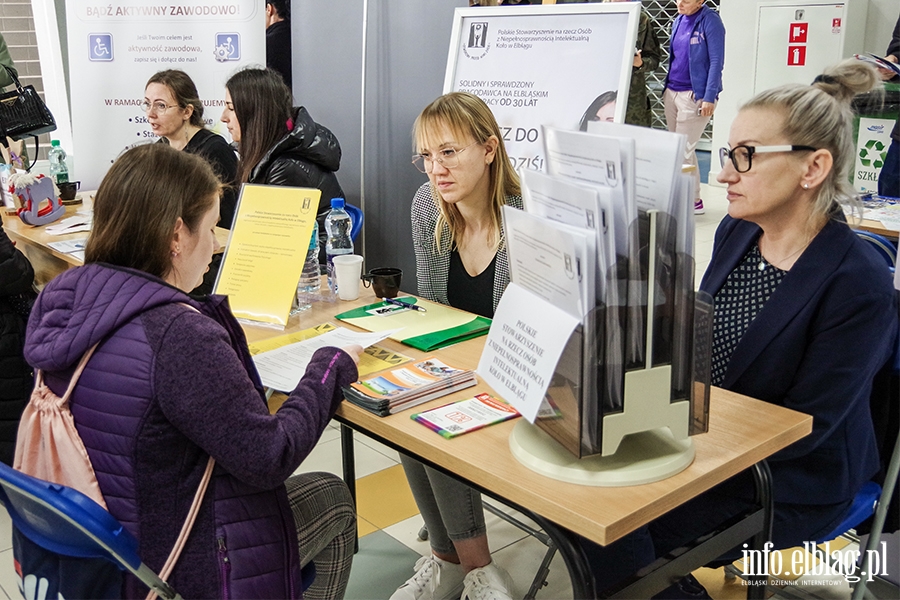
xmin=84 ymin=144 xmax=222 ymax=278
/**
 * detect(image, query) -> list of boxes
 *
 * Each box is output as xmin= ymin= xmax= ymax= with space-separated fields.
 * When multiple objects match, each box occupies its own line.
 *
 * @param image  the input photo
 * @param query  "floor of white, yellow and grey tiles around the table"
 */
xmin=0 ymin=185 xmax=888 ymax=600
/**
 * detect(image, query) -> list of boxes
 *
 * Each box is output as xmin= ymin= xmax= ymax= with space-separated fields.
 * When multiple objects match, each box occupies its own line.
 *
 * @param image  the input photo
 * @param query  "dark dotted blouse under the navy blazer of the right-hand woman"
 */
xmin=710 ymin=244 xmax=787 ymax=386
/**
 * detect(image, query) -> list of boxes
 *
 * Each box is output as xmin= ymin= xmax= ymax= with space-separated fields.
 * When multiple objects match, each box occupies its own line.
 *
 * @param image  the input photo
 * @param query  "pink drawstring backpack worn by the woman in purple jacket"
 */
xmin=13 ymin=305 xmax=216 ymax=600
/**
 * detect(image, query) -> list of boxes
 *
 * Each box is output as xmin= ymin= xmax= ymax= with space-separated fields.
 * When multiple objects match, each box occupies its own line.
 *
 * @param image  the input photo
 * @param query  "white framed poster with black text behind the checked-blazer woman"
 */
xmin=444 ymin=2 xmax=640 ymax=171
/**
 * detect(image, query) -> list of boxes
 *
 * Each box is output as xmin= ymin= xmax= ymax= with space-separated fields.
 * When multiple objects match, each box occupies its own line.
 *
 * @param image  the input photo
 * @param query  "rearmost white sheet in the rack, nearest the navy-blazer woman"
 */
xmin=588 ymin=121 xmax=685 ymax=214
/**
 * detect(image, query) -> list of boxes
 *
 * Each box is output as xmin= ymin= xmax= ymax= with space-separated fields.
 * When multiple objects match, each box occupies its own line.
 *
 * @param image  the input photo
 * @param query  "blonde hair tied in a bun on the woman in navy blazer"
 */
xmin=741 ymin=59 xmax=881 ymax=222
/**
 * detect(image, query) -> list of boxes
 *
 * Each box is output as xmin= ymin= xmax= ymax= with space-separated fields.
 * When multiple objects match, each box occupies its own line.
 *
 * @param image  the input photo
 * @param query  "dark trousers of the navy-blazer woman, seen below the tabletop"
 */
xmin=582 ymin=472 xmax=851 ymax=592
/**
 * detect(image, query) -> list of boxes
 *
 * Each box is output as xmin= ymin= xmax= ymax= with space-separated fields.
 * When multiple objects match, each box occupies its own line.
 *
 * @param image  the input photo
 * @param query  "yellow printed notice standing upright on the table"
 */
xmin=215 ymin=184 xmax=322 ymax=327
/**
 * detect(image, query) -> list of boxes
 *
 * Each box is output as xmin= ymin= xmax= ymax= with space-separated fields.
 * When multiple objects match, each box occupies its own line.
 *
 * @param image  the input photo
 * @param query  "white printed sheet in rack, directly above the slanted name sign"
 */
xmin=495 ymin=206 xmax=594 ymax=319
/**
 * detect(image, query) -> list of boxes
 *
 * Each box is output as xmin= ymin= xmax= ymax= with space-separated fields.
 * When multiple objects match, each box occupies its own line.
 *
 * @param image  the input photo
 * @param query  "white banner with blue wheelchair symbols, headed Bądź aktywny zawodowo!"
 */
xmin=66 ymin=0 xmax=266 ymax=190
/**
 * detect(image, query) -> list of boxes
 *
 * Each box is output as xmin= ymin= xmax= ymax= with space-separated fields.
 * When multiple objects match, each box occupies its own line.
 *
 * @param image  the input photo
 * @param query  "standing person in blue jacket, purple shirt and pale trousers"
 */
xmin=663 ymin=0 xmax=725 ymax=215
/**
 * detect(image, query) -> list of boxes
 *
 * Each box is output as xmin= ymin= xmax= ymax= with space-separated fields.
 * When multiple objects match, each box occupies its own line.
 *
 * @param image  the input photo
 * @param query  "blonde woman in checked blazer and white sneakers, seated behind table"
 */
xmin=391 ymin=92 xmax=522 ymax=600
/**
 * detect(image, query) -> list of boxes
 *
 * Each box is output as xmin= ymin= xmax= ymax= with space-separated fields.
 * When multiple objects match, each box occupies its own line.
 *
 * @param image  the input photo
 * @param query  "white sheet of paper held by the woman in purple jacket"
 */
xmin=253 ymin=327 xmax=397 ymax=393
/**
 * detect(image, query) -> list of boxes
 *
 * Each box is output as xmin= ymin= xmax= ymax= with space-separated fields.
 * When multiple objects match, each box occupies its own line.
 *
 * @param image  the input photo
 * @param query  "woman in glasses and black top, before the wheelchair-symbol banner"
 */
xmin=141 ymin=69 xmax=237 ymax=229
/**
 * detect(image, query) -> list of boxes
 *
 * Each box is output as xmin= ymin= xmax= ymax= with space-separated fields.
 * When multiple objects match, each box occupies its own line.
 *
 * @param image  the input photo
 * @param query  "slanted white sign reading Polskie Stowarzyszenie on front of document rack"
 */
xmin=476 ymin=283 xmax=580 ymax=423
